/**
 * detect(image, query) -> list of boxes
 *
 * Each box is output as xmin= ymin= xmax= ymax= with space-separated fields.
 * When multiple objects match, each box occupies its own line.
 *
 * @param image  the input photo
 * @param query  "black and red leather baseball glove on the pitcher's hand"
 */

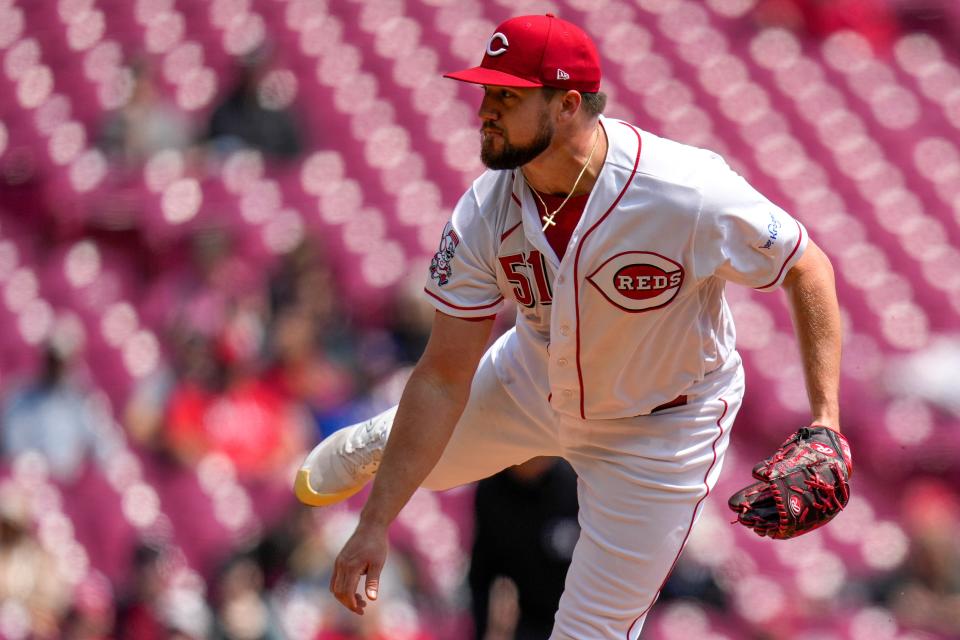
xmin=729 ymin=427 xmax=853 ymax=539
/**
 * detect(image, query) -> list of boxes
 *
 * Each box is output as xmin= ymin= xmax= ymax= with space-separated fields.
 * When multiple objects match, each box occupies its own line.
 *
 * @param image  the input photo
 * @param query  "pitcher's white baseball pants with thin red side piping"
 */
xmin=408 ymin=336 xmax=744 ymax=640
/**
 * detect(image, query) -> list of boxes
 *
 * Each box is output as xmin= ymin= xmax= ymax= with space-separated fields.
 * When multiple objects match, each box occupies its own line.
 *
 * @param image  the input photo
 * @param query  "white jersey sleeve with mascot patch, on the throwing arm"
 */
xmin=424 ymin=189 xmax=504 ymax=318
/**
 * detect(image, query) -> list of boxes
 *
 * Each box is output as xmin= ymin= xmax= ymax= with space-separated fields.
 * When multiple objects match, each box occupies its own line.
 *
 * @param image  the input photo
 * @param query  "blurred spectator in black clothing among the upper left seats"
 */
xmin=207 ymin=51 xmax=303 ymax=159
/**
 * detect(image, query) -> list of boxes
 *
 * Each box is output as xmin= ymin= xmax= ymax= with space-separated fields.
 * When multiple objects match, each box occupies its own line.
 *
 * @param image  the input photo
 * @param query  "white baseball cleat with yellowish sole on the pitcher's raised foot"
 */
xmin=293 ymin=407 xmax=397 ymax=507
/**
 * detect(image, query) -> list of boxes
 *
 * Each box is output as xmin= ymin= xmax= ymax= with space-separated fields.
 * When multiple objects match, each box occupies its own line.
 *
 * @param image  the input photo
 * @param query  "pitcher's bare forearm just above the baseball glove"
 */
xmin=784 ymin=245 xmax=841 ymax=431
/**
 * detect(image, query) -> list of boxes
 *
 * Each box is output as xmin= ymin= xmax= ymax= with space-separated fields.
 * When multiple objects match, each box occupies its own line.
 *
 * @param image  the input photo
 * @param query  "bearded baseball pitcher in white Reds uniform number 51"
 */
xmin=296 ymin=14 xmax=852 ymax=640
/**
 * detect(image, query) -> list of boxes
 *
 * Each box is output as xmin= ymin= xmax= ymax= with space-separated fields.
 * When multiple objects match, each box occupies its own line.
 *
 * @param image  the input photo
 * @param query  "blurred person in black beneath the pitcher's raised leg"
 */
xmin=469 ymin=458 xmax=580 ymax=640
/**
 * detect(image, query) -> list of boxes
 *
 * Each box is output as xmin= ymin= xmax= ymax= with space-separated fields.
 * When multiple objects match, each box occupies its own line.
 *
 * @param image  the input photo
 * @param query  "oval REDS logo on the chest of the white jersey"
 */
xmin=587 ymin=251 xmax=683 ymax=313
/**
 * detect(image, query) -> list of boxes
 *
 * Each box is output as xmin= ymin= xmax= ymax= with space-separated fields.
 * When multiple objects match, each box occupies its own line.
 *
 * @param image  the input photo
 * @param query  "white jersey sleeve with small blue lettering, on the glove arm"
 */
xmin=694 ymin=155 xmax=807 ymax=291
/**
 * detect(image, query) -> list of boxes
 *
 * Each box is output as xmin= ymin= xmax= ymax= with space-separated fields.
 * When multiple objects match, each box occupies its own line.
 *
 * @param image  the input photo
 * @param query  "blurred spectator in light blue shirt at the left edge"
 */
xmin=0 ymin=343 xmax=118 ymax=482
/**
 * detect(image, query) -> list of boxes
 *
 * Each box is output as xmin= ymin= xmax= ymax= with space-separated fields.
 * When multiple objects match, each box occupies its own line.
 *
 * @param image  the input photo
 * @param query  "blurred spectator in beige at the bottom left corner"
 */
xmin=0 ymin=483 xmax=70 ymax=639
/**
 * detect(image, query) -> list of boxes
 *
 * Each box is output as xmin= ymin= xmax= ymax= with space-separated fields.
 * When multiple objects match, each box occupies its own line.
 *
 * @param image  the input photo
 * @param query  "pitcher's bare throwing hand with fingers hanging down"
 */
xmin=330 ymin=522 xmax=387 ymax=616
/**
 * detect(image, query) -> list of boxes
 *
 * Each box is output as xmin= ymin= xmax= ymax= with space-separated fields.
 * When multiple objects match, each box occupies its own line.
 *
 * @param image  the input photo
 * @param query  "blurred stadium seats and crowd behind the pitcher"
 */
xmin=0 ymin=0 xmax=960 ymax=640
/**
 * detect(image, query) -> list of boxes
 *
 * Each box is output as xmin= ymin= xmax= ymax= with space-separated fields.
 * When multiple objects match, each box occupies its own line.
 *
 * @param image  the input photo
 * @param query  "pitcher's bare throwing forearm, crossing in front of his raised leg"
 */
xmin=361 ymin=368 xmax=470 ymax=527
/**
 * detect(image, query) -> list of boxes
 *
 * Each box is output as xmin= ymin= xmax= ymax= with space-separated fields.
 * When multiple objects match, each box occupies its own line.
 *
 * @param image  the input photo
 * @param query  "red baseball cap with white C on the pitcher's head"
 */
xmin=444 ymin=13 xmax=600 ymax=93
